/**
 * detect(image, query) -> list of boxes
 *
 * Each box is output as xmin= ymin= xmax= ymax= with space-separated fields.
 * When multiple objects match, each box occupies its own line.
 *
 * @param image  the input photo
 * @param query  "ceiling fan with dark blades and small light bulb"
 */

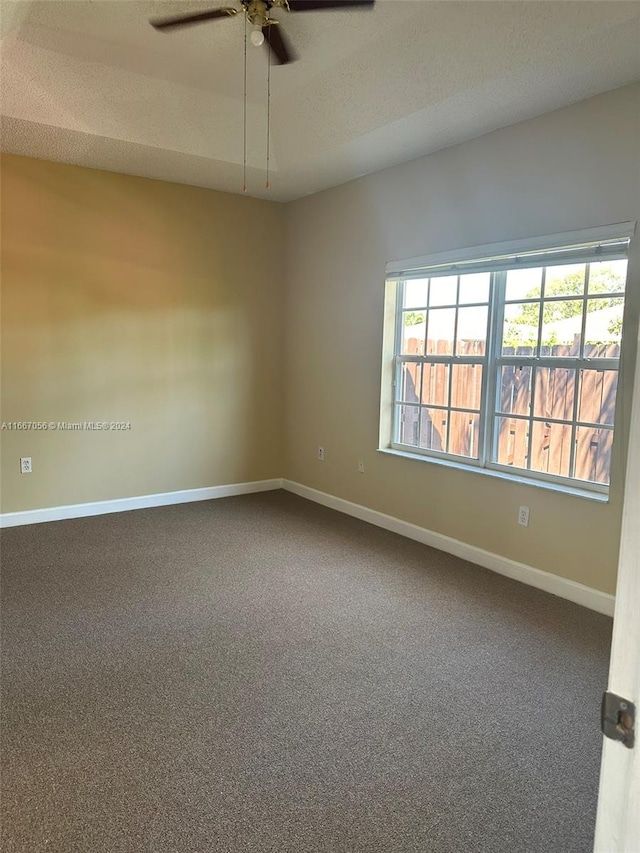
xmin=150 ymin=0 xmax=375 ymax=65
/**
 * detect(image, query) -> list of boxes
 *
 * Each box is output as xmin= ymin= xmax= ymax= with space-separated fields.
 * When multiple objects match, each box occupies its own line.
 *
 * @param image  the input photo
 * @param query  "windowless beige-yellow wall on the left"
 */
xmin=1 ymin=156 xmax=283 ymax=512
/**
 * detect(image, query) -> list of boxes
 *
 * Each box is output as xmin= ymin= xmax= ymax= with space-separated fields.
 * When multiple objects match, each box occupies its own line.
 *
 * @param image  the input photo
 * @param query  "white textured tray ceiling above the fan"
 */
xmin=0 ymin=0 xmax=640 ymax=201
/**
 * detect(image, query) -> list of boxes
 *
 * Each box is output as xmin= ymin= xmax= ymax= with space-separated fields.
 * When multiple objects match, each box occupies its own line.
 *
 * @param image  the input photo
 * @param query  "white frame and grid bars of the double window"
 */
xmin=380 ymin=222 xmax=636 ymax=499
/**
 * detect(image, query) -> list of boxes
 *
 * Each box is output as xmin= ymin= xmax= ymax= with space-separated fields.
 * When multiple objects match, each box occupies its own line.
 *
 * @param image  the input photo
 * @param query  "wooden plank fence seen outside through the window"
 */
xmin=400 ymin=339 xmax=620 ymax=483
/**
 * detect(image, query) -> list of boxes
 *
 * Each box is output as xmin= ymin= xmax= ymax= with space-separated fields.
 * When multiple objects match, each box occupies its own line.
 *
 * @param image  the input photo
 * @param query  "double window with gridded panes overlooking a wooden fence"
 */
xmin=383 ymin=226 xmax=632 ymax=493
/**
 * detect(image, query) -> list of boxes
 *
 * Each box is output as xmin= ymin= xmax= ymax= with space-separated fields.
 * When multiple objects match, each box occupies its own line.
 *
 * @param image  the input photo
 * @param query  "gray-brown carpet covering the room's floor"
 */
xmin=2 ymin=492 xmax=611 ymax=853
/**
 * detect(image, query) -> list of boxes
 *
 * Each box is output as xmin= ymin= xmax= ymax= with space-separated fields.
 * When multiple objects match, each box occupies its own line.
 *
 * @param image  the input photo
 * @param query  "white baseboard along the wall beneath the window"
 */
xmin=282 ymin=480 xmax=615 ymax=616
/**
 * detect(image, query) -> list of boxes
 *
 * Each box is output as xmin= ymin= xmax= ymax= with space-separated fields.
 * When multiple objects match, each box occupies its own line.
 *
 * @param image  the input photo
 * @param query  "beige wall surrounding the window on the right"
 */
xmin=284 ymin=85 xmax=640 ymax=593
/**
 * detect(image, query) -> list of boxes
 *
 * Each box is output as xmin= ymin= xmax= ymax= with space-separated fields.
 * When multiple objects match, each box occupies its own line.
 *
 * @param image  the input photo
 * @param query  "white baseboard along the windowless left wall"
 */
xmin=0 ymin=479 xmax=282 ymax=528
